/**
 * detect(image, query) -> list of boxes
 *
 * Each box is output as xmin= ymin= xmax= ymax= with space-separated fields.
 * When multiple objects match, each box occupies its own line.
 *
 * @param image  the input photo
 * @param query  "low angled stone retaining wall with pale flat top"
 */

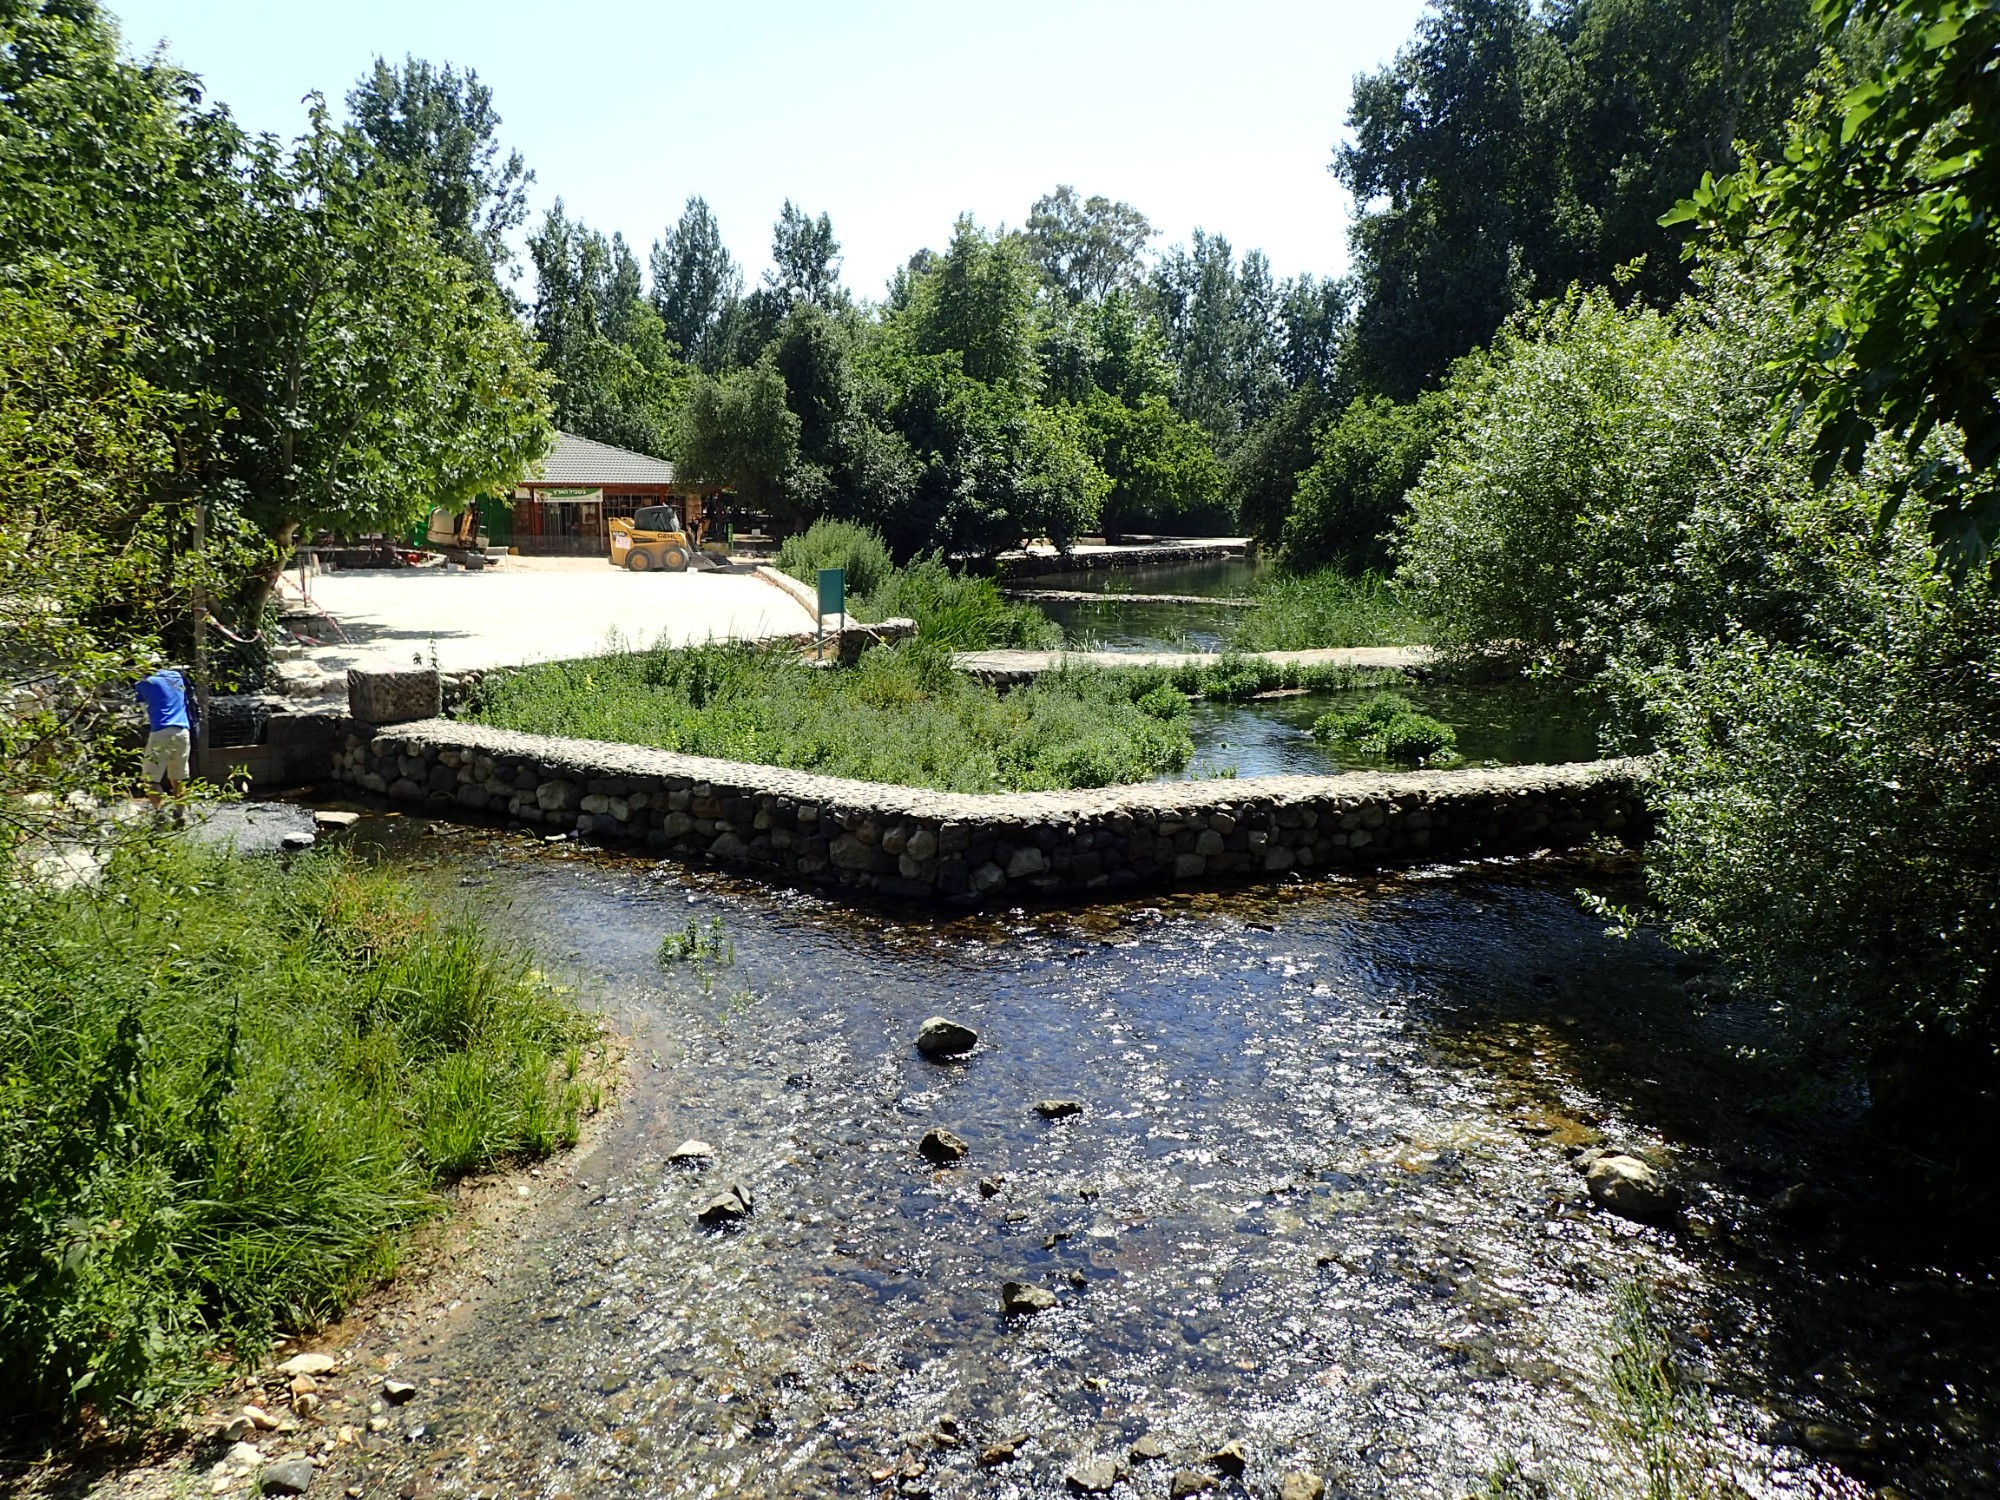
xmin=332 ymin=720 xmax=1644 ymax=902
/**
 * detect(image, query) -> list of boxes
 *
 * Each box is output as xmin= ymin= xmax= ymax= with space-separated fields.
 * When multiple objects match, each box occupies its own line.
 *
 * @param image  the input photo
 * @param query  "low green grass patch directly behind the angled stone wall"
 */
xmin=472 ymin=640 xmax=1194 ymax=792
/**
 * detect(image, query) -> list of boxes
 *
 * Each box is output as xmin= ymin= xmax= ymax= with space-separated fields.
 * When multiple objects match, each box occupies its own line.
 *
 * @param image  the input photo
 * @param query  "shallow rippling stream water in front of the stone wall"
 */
xmin=332 ymin=820 xmax=2000 ymax=1498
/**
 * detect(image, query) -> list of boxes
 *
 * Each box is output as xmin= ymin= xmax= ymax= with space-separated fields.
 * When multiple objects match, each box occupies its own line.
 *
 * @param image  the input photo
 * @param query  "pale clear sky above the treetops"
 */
xmin=108 ymin=0 xmax=1422 ymax=298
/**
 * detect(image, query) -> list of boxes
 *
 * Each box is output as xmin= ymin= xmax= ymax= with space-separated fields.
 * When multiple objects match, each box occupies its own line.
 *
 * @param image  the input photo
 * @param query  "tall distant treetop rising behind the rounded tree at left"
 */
xmin=348 ymin=56 xmax=534 ymax=274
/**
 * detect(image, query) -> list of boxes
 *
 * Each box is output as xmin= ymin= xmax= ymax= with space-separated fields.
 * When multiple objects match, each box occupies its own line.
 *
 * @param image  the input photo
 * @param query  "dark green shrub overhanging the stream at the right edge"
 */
xmin=1636 ymin=512 xmax=2000 ymax=1144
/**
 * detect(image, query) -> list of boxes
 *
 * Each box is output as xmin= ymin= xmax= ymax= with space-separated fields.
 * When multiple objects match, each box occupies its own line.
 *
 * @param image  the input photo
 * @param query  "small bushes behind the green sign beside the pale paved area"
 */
xmin=778 ymin=520 xmax=1062 ymax=652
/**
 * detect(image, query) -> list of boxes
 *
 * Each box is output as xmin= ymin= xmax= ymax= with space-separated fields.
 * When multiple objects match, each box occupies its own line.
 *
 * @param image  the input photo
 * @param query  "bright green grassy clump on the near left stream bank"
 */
xmin=0 ymin=842 xmax=596 ymax=1424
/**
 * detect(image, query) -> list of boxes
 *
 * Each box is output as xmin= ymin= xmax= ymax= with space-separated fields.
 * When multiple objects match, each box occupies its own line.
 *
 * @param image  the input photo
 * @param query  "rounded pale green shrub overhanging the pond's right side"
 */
xmin=1398 ymin=282 xmax=1816 ymax=672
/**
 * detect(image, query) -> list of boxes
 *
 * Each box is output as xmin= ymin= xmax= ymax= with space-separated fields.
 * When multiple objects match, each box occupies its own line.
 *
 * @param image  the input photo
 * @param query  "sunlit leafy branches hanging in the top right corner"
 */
xmin=1664 ymin=0 xmax=2000 ymax=558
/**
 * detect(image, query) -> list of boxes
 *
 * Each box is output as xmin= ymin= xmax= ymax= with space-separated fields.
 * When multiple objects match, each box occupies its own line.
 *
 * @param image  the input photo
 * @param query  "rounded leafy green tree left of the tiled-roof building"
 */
xmin=186 ymin=102 xmax=548 ymax=626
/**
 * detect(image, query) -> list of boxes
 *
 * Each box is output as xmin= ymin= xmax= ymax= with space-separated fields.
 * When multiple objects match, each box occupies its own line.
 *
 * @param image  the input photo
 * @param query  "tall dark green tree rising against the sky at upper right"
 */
xmin=1332 ymin=0 xmax=1816 ymax=400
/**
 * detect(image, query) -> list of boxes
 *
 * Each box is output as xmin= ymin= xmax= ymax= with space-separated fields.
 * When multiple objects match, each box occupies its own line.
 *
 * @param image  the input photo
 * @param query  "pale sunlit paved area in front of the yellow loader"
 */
xmin=284 ymin=558 xmax=812 ymax=680
